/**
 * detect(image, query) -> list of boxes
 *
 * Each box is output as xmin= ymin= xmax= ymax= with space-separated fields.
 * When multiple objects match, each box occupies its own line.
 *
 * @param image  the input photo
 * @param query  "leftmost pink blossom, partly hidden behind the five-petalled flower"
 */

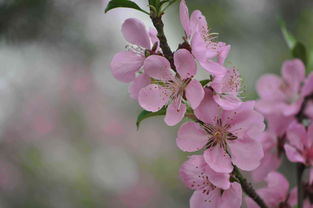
xmin=111 ymin=18 xmax=159 ymax=99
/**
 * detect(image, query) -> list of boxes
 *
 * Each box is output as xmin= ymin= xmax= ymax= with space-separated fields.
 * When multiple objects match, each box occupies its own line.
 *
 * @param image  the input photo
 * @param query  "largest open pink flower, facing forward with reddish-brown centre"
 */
xmin=176 ymin=89 xmax=264 ymax=173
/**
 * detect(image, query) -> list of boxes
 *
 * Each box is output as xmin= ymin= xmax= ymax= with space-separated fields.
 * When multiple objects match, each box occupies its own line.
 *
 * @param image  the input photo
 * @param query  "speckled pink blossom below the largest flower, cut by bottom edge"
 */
xmin=179 ymin=155 xmax=242 ymax=208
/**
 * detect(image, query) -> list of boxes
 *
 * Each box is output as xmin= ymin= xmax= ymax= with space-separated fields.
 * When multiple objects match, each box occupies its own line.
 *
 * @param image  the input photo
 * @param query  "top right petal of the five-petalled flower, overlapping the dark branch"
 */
xmin=174 ymin=49 xmax=197 ymax=79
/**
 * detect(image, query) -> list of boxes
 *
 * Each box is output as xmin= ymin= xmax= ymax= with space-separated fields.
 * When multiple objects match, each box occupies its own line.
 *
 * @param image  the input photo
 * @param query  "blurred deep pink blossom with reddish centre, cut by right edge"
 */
xmin=284 ymin=121 xmax=313 ymax=183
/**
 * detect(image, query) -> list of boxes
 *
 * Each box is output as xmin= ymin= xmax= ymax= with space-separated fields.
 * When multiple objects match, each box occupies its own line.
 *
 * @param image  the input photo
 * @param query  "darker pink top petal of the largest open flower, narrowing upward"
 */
xmin=194 ymin=89 xmax=221 ymax=124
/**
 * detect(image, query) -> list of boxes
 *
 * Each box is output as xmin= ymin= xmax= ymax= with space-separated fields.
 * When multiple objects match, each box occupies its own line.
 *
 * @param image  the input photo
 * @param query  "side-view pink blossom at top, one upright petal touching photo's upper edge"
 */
xmin=180 ymin=0 xmax=230 ymax=75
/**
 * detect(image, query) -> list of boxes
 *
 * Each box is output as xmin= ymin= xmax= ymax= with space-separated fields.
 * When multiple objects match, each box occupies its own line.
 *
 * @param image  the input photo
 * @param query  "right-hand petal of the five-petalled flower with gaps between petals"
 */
xmin=185 ymin=79 xmax=205 ymax=109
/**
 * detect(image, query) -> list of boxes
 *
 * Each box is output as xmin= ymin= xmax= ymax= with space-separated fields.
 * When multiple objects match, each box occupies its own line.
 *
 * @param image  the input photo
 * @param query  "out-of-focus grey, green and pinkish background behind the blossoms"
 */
xmin=0 ymin=0 xmax=313 ymax=208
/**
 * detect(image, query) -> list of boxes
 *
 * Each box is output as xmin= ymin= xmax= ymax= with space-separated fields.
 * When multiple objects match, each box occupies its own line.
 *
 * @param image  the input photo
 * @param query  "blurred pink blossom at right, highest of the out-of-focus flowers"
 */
xmin=256 ymin=59 xmax=305 ymax=116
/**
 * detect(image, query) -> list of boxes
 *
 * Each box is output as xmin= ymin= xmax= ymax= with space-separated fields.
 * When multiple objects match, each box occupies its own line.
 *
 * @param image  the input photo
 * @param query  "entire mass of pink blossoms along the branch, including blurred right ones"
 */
xmin=111 ymin=0 xmax=313 ymax=208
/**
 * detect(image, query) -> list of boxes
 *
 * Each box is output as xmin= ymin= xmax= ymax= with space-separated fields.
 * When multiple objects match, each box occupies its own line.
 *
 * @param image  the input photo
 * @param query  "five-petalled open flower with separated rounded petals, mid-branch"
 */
xmin=138 ymin=49 xmax=204 ymax=126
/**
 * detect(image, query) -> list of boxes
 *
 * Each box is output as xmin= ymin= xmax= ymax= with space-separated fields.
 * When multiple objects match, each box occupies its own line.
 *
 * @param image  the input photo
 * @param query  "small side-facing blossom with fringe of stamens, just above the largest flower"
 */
xmin=210 ymin=68 xmax=242 ymax=110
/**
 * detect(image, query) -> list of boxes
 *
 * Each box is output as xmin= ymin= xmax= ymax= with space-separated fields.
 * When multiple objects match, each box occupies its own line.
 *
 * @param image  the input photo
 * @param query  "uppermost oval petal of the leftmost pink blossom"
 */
xmin=122 ymin=18 xmax=151 ymax=49
